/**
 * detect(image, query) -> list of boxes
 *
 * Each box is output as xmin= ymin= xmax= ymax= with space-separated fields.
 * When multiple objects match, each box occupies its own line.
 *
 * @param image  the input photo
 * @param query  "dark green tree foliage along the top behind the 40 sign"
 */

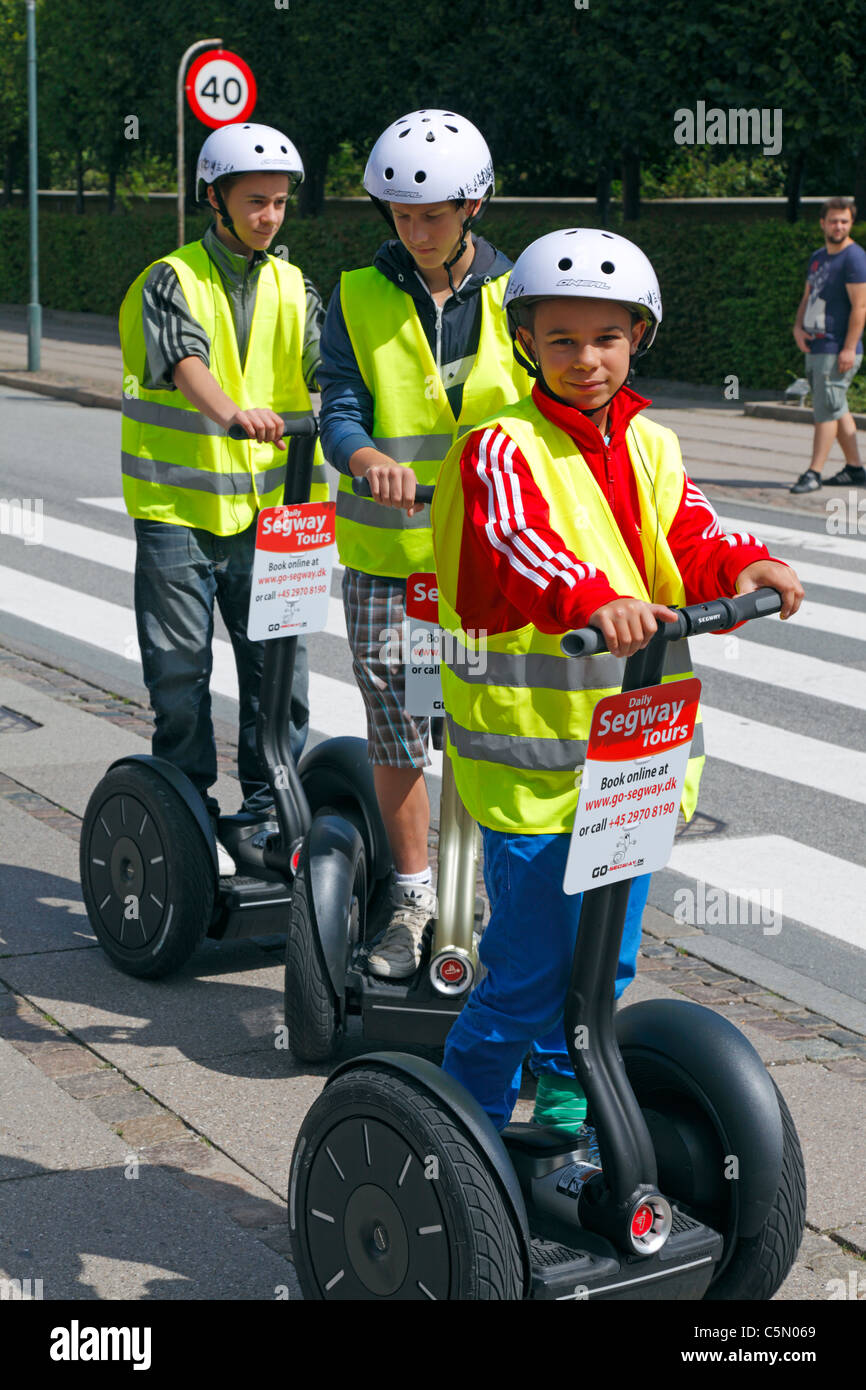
xmin=0 ymin=0 xmax=866 ymax=217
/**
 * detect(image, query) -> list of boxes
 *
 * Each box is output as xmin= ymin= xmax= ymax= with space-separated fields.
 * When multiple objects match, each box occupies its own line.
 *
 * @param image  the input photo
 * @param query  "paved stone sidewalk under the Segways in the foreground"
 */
xmin=0 ymin=648 xmax=866 ymax=1300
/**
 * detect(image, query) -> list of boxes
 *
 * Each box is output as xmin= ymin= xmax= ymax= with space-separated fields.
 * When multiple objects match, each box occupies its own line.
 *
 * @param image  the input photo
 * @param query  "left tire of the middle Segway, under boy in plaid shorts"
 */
xmin=284 ymin=848 xmax=367 ymax=1062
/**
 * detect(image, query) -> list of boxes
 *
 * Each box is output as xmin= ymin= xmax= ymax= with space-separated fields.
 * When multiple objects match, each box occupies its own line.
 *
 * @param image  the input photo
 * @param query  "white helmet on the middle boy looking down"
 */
xmin=364 ymin=110 xmax=493 ymax=203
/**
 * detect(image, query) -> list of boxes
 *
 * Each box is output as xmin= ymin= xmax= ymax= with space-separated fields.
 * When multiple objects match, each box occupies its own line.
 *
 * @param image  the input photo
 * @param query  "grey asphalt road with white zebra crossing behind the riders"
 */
xmin=0 ymin=388 xmax=866 ymax=1022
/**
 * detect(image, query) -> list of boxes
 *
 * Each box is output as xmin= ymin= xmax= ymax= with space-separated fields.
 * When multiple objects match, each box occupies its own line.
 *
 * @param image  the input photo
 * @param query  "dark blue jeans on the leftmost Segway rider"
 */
xmin=135 ymin=521 xmax=310 ymax=817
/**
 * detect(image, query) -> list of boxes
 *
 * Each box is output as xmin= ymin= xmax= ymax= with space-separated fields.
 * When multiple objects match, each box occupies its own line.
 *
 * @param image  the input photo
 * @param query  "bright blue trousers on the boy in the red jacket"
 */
xmin=443 ymin=826 xmax=651 ymax=1129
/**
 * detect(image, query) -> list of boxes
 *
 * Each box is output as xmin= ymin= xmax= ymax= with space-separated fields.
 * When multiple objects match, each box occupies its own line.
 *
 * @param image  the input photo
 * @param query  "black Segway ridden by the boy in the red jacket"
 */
xmin=289 ymin=589 xmax=805 ymax=1301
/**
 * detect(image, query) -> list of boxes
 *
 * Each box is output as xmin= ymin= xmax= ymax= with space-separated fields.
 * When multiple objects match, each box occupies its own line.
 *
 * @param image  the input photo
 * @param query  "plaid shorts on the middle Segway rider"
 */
xmin=343 ymin=569 xmax=431 ymax=767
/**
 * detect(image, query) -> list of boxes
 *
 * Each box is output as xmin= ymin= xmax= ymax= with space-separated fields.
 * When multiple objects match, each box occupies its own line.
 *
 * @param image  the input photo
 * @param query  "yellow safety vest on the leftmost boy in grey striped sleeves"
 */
xmin=120 ymin=242 xmax=328 ymax=535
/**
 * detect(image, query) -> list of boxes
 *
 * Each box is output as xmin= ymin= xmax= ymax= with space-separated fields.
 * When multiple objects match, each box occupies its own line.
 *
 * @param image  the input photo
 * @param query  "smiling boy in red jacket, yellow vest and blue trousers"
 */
xmin=432 ymin=228 xmax=803 ymax=1130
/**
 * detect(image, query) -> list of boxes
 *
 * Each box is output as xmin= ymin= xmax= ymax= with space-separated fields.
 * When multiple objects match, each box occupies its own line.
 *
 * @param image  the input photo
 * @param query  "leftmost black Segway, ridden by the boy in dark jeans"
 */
xmin=79 ymin=416 xmax=391 ymax=979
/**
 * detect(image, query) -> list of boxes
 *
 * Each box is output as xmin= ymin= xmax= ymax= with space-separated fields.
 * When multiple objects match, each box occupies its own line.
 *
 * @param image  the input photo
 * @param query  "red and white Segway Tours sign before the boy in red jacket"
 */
xmin=563 ymin=677 xmax=701 ymax=892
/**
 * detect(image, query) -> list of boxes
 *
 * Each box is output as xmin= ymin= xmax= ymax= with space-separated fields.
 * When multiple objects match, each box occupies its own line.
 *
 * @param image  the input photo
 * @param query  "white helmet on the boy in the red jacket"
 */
xmin=502 ymin=227 xmax=662 ymax=356
